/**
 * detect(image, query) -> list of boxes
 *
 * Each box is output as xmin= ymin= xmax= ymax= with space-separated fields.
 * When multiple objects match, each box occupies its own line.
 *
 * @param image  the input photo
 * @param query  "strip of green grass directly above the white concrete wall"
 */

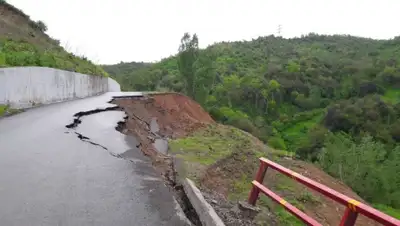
xmin=0 ymin=39 xmax=108 ymax=76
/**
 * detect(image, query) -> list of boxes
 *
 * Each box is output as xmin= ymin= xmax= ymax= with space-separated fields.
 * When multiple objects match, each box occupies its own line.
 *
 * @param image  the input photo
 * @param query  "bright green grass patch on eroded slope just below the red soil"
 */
xmin=169 ymin=124 xmax=265 ymax=182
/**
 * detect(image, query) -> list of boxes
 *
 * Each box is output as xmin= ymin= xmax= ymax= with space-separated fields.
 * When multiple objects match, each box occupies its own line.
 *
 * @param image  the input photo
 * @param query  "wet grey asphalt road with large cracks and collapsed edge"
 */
xmin=0 ymin=93 xmax=191 ymax=226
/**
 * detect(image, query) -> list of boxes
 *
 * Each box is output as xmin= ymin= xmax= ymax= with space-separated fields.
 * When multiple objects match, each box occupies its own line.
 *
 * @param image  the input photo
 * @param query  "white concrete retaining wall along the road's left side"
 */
xmin=0 ymin=67 xmax=120 ymax=109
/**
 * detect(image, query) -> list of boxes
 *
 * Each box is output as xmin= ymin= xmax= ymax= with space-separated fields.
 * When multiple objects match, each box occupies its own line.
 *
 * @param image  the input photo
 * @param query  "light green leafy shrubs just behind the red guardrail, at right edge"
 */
xmin=319 ymin=133 xmax=400 ymax=208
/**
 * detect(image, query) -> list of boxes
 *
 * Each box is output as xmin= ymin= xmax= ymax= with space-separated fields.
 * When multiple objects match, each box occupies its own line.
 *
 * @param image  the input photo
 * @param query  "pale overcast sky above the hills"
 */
xmin=7 ymin=0 xmax=400 ymax=64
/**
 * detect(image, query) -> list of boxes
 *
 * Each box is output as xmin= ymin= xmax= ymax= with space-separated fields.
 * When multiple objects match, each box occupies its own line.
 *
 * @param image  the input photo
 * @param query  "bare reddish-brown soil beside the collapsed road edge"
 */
xmin=114 ymin=93 xmax=214 ymax=156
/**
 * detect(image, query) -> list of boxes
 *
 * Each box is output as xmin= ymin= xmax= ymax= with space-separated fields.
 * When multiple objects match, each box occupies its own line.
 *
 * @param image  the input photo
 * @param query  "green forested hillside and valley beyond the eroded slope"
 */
xmin=103 ymin=33 xmax=400 ymax=218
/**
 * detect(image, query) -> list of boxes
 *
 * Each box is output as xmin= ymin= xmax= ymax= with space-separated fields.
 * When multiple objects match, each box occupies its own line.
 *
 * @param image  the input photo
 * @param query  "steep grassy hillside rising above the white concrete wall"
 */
xmin=0 ymin=0 xmax=108 ymax=76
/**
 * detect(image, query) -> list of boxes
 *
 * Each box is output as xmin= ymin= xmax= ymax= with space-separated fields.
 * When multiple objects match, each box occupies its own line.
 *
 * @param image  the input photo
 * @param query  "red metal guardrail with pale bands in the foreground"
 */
xmin=249 ymin=158 xmax=400 ymax=226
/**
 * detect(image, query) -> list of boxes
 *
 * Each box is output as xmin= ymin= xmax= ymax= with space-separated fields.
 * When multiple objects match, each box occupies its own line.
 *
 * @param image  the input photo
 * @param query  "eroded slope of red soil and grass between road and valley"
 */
xmin=114 ymin=93 xmax=382 ymax=225
